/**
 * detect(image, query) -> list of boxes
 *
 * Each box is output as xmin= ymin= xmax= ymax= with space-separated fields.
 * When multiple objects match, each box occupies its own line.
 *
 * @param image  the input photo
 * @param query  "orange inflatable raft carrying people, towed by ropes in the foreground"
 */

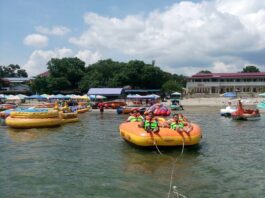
xmin=120 ymin=122 xmax=202 ymax=147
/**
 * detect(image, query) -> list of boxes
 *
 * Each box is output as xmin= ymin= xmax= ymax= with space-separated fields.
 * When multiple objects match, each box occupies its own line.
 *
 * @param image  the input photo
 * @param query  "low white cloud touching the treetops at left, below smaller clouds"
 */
xmin=23 ymin=48 xmax=73 ymax=76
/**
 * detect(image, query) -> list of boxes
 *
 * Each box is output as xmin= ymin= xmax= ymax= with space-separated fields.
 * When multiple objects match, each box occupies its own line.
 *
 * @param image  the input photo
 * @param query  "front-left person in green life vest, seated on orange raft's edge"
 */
xmin=138 ymin=111 xmax=160 ymax=133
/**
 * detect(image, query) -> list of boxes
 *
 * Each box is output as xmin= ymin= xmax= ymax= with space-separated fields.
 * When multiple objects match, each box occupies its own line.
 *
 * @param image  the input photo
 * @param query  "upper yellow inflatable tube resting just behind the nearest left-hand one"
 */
xmin=10 ymin=110 xmax=59 ymax=119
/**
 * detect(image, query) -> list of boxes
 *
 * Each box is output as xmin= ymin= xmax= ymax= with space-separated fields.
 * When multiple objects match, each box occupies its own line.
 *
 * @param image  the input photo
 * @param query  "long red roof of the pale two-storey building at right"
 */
xmin=191 ymin=72 xmax=265 ymax=78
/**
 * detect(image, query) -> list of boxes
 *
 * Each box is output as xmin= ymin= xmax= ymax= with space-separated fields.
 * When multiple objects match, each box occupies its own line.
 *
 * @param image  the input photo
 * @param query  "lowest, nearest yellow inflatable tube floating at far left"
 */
xmin=6 ymin=116 xmax=62 ymax=128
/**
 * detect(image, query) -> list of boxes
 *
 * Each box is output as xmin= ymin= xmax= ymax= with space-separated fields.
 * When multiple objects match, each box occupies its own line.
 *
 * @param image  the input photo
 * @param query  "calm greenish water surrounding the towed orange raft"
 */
xmin=0 ymin=108 xmax=265 ymax=198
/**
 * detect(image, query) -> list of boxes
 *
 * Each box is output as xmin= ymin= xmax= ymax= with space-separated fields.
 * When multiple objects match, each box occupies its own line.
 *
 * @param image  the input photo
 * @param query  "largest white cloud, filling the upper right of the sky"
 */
xmin=69 ymin=0 xmax=265 ymax=73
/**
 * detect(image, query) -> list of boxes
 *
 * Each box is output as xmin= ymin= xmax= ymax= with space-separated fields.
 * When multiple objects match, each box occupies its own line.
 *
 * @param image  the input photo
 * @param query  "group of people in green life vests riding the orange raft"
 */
xmin=126 ymin=109 xmax=193 ymax=133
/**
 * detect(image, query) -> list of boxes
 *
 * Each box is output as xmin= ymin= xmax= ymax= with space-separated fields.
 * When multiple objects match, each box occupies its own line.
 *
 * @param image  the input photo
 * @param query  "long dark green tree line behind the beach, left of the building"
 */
xmin=31 ymin=58 xmax=186 ymax=94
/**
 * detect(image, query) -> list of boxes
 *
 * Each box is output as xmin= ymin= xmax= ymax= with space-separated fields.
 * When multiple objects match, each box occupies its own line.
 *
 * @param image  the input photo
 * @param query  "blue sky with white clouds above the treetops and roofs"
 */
xmin=0 ymin=0 xmax=265 ymax=76
